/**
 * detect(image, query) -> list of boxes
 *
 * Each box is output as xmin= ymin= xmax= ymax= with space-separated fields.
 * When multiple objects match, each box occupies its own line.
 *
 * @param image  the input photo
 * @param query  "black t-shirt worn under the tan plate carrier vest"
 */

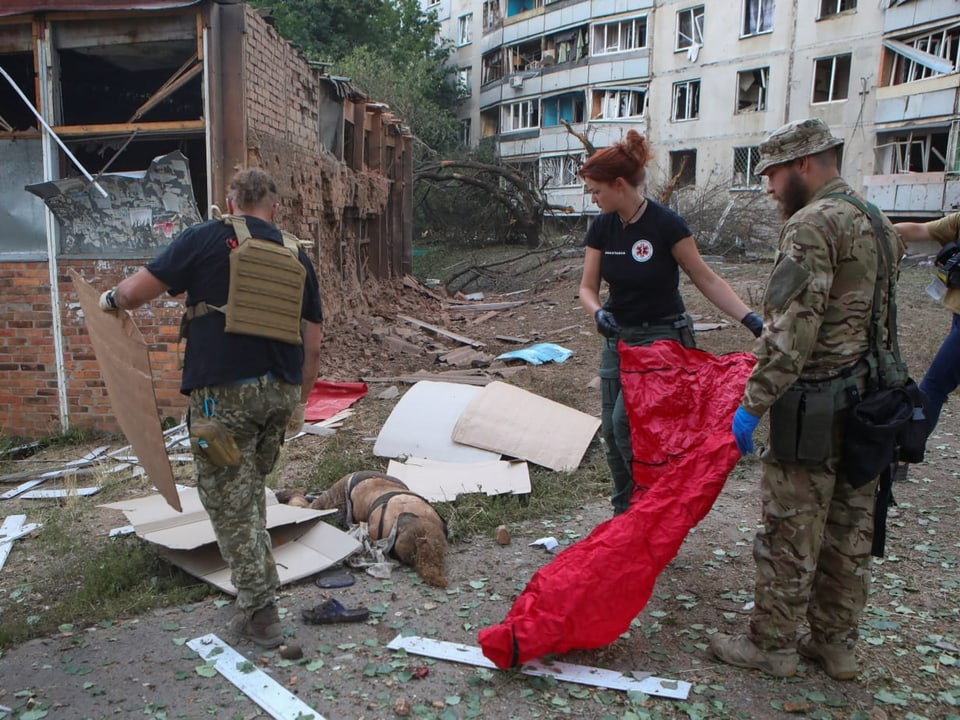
xmin=146 ymin=216 xmax=323 ymax=395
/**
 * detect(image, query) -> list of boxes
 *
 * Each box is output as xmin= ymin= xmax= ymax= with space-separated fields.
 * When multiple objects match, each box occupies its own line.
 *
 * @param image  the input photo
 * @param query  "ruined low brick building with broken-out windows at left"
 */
xmin=0 ymin=0 xmax=412 ymax=437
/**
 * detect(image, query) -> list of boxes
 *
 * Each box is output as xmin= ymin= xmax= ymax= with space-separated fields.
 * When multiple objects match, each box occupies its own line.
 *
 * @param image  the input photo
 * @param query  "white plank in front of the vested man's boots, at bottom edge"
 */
xmin=187 ymin=634 xmax=324 ymax=720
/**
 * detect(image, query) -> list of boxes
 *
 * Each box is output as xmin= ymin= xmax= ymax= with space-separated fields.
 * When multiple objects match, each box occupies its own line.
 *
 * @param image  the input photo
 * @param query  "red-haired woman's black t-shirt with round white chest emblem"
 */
xmin=584 ymin=199 xmax=691 ymax=327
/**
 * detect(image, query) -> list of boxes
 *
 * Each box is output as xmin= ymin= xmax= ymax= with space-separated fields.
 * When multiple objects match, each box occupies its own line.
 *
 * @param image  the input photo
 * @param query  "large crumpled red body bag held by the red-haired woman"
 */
xmin=478 ymin=340 xmax=755 ymax=668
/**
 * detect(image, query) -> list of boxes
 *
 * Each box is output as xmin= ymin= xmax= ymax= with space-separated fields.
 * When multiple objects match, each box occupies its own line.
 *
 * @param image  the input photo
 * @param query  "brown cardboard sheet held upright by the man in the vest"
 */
xmin=70 ymin=269 xmax=181 ymax=510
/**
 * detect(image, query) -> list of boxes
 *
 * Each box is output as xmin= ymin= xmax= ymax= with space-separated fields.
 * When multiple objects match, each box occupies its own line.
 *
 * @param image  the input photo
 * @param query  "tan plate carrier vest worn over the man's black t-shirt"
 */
xmin=181 ymin=215 xmax=307 ymax=345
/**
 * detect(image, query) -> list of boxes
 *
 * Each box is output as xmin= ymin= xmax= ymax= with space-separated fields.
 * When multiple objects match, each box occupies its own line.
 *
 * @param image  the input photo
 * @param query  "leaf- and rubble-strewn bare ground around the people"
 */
xmin=0 ymin=249 xmax=960 ymax=720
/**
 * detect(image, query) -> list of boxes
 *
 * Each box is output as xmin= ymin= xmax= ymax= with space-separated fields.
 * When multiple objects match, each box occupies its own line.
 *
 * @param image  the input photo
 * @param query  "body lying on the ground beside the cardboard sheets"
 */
xmin=277 ymin=470 xmax=447 ymax=588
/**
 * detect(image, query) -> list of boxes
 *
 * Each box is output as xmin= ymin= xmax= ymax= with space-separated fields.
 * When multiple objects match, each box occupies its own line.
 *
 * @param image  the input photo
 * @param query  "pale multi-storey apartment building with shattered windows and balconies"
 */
xmin=436 ymin=0 xmax=960 ymax=219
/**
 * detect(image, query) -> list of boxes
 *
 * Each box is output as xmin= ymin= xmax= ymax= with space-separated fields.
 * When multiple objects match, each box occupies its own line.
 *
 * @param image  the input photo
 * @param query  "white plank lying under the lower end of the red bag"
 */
xmin=387 ymin=635 xmax=692 ymax=700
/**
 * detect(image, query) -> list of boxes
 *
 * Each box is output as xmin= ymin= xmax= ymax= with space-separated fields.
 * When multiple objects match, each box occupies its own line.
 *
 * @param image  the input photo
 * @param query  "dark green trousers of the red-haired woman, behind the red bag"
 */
xmin=597 ymin=317 xmax=696 ymax=515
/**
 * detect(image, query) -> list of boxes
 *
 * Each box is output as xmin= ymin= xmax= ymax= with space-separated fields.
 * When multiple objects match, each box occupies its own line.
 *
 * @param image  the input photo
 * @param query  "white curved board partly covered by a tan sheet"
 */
xmin=373 ymin=380 xmax=500 ymax=463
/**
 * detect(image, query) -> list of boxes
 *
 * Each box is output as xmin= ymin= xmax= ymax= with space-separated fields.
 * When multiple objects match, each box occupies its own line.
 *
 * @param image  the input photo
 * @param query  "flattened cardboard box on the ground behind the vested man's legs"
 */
xmin=101 ymin=488 xmax=360 ymax=595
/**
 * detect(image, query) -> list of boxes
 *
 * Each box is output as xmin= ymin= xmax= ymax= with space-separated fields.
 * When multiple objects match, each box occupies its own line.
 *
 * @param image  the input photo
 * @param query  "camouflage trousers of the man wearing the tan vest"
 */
xmin=190 ymin=376 xmax=300 ymax=614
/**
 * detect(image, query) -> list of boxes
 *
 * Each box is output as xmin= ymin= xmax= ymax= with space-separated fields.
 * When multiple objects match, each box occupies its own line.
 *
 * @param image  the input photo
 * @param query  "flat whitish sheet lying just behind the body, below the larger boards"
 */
xmin=387 ymin=458 xmax=531 ymax=502
